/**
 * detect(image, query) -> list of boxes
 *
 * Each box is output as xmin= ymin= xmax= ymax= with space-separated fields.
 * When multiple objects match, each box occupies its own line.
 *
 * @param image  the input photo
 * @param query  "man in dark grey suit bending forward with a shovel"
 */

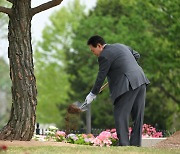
xmin=85 ymin=35 xmax=150 ymax=146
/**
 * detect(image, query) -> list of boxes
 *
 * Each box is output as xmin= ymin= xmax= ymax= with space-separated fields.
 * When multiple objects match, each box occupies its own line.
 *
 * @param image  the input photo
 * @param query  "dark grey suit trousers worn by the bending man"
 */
xmin=114 ymin=84 xmax=146 ymax=146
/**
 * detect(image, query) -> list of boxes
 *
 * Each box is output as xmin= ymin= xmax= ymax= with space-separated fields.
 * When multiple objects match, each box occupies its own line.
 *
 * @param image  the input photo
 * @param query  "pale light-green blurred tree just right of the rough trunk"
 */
xmin=35 ymin=0 xmax=85 ymax=128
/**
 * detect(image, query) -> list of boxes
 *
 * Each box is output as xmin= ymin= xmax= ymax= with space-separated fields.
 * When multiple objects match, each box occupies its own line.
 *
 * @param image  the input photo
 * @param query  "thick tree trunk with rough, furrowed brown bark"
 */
xmin=0 ymin=0 xmax=37 ymax=141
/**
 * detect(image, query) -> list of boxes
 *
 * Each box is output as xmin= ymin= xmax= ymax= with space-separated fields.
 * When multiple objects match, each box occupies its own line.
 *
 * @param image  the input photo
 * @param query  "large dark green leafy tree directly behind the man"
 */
xmin=66 ymin=0 xmax=180 ymax=129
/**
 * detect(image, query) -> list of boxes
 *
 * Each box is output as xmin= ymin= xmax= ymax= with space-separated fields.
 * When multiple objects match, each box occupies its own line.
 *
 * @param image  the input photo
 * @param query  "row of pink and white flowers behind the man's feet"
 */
xmin=33 ymin=124 xmax=163 ymax=146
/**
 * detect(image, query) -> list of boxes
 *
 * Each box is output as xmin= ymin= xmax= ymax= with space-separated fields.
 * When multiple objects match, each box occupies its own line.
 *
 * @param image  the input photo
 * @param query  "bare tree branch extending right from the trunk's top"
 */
xmin=31 ymin=0 xmax=63 ymax=16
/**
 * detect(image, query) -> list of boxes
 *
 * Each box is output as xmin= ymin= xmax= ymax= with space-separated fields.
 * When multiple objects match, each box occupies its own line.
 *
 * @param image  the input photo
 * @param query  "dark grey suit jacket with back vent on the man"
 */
xmin=92 ymin=43 xmax=150 ymax=102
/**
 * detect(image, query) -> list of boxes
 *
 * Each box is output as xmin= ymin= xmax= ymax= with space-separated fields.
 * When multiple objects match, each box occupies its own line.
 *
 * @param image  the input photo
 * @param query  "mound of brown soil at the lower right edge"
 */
xmin=154 ymin=131 xmax=180 ymax=149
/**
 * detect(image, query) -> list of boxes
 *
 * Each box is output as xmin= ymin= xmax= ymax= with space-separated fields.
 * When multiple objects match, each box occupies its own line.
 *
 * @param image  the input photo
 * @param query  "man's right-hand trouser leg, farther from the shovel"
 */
xmin=130 ymin=84 xmax=146 ymax=146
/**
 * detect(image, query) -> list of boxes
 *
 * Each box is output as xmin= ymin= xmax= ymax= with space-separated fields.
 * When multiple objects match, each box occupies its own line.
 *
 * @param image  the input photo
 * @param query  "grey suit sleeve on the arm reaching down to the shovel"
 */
xmin=91 ymin=56 xmax=110 ymax=95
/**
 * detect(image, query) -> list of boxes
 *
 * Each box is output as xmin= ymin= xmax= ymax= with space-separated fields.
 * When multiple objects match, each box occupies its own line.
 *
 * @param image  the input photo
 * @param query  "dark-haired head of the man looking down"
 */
xmin=87 ymin=35 xmax=106 ymax=56
